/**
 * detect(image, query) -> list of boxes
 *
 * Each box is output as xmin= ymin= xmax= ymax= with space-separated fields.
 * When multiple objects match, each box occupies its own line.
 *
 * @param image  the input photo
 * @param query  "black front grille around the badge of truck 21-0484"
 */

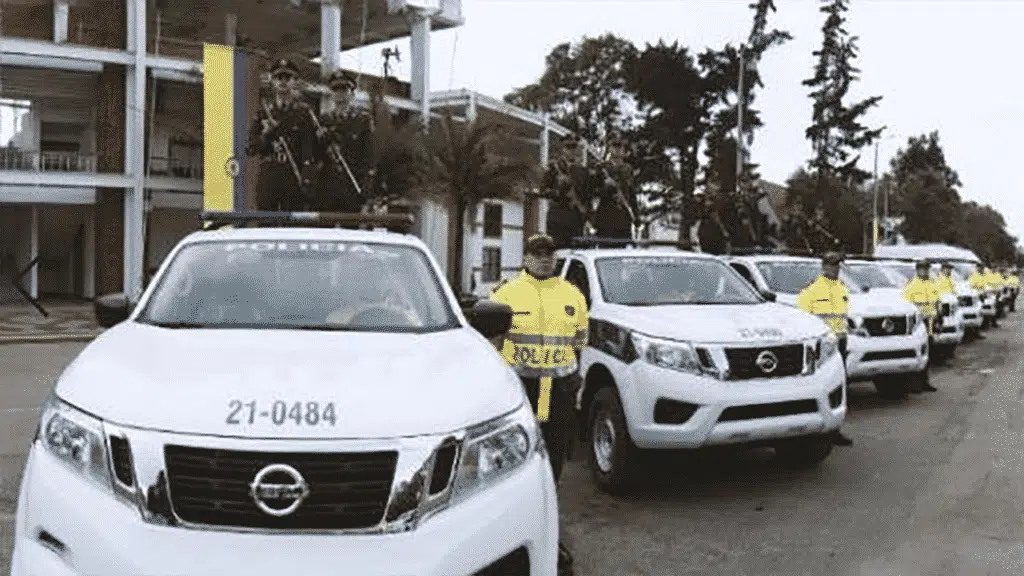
xmin=164 ymin=445 xmax=398 ymax=530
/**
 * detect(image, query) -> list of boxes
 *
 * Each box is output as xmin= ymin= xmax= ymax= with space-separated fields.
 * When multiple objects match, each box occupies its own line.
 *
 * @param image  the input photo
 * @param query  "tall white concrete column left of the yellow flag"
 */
xmin=124 ymin=1 xmax=145 ymax=299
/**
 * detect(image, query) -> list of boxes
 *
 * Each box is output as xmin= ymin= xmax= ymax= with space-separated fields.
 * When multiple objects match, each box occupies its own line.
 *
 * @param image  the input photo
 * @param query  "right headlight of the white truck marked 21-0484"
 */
xmin=453 ymin=404 xmax=544 ymax=499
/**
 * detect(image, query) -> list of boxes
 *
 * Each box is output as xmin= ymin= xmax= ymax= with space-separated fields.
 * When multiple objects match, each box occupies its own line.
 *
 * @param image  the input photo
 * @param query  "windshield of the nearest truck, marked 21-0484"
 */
xmin=138 ymin=241 xmax=459 ymax=332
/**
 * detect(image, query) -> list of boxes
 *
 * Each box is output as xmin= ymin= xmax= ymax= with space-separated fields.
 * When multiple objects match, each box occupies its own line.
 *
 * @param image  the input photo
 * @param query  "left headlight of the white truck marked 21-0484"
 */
xmin=39 ymin=396 xmax=112 ymax=488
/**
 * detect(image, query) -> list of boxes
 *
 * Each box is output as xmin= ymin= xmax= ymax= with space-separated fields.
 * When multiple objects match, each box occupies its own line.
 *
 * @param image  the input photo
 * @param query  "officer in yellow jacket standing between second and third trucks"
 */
xmin=797 ymin=252 xmax=853 ymax=446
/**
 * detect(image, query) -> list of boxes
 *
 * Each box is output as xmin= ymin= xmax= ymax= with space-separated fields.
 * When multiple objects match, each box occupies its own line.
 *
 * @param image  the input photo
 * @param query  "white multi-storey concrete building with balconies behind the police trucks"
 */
xmin=0 ymin=0 xmax=567 ymax=300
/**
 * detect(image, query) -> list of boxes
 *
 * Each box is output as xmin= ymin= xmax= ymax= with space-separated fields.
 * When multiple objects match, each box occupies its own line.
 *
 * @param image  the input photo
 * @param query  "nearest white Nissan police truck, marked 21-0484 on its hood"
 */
xmin=11 ymin=214 xmax=558 ymax=576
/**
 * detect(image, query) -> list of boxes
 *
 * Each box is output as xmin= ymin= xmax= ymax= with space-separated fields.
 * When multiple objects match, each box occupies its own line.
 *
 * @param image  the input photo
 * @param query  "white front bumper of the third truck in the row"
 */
xmin=846 ymin=325 xmax=929 ymax=381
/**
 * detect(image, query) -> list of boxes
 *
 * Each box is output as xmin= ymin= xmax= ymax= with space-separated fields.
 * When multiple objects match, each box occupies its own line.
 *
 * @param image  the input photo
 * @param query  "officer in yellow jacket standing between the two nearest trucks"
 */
xmin=490 ymin=234 xmax=590 ymax=573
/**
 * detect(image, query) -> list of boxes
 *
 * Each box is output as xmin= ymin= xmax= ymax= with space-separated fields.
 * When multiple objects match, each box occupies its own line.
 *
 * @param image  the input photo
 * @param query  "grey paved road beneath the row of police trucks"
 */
xmin=0 ymin=314 xmax=1024 ymax=576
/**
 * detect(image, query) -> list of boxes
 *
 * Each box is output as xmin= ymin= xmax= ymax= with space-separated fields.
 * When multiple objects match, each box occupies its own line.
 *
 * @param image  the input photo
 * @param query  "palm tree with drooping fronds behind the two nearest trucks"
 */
xmin=413 ymin=116 xmax=538 ymax=294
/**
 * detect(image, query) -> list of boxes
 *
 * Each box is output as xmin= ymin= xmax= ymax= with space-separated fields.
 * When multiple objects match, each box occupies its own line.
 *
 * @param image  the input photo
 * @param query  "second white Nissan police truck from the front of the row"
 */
xmin=560 ymin=238 xmax=847 ymax=491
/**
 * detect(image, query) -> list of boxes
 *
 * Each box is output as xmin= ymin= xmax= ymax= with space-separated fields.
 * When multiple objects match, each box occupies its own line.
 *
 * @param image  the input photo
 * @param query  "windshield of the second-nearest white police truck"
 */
xmin=596 ymin=256 xmax=764 ymax=305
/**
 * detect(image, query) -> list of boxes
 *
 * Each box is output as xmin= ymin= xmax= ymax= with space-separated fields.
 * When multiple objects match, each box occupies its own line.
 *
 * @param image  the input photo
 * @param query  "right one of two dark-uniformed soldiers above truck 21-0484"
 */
xmin=313 ymin=70 xmax=374 ymax=212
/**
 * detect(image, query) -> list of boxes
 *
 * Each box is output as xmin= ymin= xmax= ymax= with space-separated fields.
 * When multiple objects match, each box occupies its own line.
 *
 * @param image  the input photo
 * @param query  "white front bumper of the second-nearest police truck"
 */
xmin=615 ymin=353 xmax=847 ymax=449
